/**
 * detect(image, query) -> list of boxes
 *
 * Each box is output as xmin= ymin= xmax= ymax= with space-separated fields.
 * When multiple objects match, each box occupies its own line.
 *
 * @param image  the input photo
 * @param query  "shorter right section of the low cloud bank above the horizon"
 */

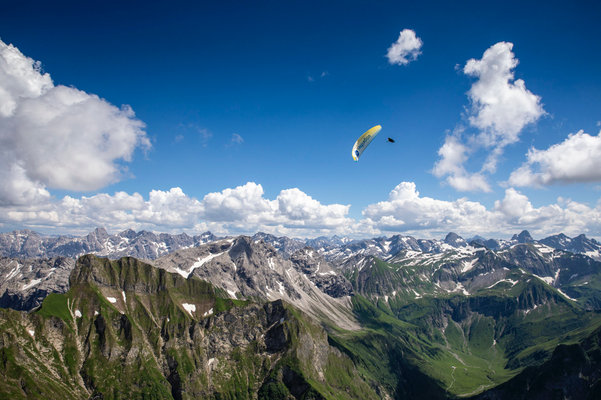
xmin=363 ymin=182 xmax=601 ymax=241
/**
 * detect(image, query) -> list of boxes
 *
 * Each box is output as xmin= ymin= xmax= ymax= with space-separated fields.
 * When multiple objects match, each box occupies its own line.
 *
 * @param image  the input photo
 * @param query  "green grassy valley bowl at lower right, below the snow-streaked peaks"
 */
xmin=340 ymin=259 xmax=601 ymax=398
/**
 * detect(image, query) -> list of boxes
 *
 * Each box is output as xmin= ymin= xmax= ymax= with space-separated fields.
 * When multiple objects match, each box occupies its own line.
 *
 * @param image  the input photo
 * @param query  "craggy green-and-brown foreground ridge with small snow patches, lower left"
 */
xmin=0 ymin=255 xmax=378 ymax=399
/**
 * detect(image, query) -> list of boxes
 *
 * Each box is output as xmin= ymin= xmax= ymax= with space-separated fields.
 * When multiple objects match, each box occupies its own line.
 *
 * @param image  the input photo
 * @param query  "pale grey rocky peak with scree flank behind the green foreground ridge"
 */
xmin=152 ymin=236 xmax=359 ymax=330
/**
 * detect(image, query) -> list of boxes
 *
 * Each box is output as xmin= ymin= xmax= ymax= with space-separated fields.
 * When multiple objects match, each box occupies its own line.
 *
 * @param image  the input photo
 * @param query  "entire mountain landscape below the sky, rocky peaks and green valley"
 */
xmin=0 ymin=228 xmax=601 ymax=400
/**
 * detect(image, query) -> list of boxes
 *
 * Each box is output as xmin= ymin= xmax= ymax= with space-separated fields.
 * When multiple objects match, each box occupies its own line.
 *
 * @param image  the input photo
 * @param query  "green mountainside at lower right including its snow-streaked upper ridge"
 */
xmin=333 ymin=255 xmax=601 ymax=398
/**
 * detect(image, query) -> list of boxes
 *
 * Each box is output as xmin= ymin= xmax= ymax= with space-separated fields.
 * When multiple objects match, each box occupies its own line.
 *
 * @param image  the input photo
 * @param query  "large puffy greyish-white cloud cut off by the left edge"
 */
xmin=0 ymin=41 xmax=150 ymax=203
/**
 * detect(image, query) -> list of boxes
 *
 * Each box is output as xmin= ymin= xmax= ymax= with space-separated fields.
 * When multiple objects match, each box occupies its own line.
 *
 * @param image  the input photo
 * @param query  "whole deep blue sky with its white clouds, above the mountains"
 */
xmin=0 ymin=0 xmax=601 ymax=239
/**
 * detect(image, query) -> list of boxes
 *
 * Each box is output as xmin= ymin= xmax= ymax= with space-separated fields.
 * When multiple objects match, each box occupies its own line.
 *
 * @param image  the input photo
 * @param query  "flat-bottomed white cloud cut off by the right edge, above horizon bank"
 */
xmin=508 ymin=131 xmax=601 ymax=187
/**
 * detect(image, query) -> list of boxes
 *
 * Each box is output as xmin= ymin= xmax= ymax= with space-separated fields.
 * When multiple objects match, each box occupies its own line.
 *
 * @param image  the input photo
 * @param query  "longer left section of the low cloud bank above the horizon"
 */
xmin=0 ymin=182 xmax=353 ymax=236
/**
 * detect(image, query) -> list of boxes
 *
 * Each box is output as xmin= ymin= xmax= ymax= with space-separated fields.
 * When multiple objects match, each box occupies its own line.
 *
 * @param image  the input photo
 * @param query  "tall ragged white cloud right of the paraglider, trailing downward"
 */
xmin=432 ymin=42 xmax=545 ymax=192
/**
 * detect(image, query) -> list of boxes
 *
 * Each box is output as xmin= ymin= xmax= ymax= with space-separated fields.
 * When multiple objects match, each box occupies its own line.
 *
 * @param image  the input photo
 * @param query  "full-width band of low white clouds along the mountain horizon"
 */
xmin=0 ymin=182 xmax=601 ymax=238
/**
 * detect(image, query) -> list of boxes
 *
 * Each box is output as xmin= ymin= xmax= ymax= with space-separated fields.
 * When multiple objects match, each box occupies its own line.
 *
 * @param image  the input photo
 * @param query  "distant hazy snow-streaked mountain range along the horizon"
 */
xmin=0 ymin=228 xmax=601 ymax=261
